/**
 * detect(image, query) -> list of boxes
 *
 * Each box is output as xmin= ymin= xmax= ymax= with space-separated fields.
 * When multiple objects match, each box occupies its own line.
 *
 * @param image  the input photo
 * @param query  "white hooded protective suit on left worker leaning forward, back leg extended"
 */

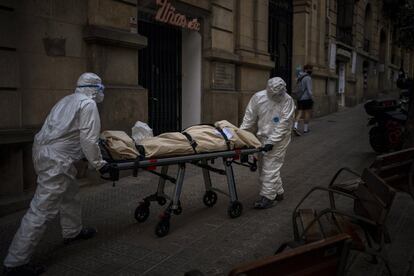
xmin=4 ymin=73 xmax=106 ymax=267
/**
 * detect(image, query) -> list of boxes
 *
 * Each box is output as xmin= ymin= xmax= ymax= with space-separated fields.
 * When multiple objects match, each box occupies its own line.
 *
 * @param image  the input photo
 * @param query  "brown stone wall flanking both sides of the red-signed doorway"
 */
xmin=0 ymin=0 xmax=274 ymax=212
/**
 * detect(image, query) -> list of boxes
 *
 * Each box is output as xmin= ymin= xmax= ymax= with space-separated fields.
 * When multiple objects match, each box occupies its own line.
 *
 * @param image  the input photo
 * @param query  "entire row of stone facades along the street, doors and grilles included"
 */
xmin=0 ymin=0 xmax=414 ymax=215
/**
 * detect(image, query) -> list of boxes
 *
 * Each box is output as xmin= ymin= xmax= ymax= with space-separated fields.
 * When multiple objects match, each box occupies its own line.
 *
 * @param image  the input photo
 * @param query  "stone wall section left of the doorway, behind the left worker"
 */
xmin=0 ymin=0 xmax=147 ymax=215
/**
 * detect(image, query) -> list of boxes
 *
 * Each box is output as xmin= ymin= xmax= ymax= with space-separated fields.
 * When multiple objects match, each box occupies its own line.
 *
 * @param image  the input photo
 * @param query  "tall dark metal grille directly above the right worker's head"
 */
xmin=268 ymin=0 xmax=293 ymax=91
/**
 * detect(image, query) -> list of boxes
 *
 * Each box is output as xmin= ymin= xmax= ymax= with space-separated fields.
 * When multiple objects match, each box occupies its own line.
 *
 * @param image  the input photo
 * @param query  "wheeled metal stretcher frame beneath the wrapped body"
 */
xmin=102 ymin=146 xmax=261 ymax=237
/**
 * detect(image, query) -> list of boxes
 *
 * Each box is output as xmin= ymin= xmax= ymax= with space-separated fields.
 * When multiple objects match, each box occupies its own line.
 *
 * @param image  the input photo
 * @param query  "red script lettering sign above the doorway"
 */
xmin=155 ymin=0 xmax=200 ymax=31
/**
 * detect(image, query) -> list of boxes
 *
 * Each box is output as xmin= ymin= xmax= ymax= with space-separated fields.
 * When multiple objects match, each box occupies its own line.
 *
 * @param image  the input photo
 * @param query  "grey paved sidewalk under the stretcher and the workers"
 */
xmin=0 ymin=106 xmax=414 ymax=276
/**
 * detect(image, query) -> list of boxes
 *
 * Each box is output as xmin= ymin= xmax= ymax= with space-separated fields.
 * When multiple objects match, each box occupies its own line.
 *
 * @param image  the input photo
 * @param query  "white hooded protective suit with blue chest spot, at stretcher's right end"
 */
xmin=240 ymin=77 xmax=295 ymax=200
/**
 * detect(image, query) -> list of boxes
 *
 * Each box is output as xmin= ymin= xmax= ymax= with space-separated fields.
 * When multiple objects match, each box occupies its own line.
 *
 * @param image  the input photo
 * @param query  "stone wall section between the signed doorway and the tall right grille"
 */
xmin=203 ymin=0 xmax=273 ymax=125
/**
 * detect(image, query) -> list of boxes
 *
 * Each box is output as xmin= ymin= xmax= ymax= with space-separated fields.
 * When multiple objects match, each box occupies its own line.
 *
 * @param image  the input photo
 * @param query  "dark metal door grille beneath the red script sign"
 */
xmin=138 ymin=21 xmax=181 ymax=135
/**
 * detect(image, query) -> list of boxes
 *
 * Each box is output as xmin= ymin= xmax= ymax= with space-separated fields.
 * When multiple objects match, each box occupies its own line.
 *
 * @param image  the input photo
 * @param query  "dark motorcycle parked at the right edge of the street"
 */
xmin=364 ymin=91 xmax=408 ymax=153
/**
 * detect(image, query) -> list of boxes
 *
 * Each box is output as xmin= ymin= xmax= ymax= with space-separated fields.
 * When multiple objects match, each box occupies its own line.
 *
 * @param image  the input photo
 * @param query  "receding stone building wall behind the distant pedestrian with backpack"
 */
xmin=292 ymin=0 xmax=412 ymax=116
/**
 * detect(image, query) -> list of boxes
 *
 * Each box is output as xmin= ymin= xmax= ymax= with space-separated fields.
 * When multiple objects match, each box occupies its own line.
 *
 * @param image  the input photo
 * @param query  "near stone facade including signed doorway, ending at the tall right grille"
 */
xmin=0 ymin=0 xmax=274 ymax=215
